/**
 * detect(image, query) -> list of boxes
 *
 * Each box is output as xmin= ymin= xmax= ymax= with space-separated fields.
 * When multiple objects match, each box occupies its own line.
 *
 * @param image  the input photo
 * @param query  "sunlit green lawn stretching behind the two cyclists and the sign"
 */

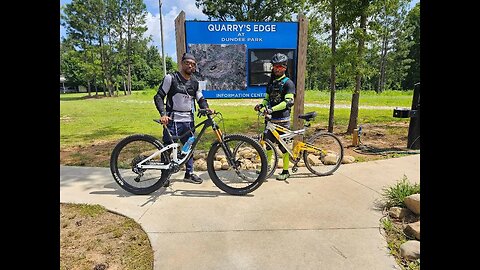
xmin=60 ymin=89 xmax=413 ymax=149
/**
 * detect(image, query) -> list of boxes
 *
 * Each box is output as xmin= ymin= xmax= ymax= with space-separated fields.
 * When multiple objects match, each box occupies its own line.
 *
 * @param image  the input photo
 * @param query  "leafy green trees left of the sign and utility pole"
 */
xmin=60 ymin=0 xmax=173 ymax=96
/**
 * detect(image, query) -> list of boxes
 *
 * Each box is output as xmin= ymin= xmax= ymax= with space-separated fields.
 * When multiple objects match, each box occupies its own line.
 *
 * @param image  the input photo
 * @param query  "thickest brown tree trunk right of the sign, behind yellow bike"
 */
xmin=347 ymin=0 xmax=368 ymax=134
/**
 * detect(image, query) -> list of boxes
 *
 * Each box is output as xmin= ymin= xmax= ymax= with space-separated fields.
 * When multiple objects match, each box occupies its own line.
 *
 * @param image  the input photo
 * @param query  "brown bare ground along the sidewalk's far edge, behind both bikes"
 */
xmin=60 ymin=122 xmax=416 ymax=167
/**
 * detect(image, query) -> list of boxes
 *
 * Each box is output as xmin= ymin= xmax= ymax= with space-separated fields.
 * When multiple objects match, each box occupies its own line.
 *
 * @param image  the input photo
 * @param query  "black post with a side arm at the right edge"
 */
xmin=393 ymin=83 xmax=420 ymax=149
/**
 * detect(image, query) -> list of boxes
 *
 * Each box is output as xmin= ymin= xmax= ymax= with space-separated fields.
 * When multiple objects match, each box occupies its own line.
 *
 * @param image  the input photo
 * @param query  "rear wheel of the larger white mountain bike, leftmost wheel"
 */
xmin=110 ymin=134 xmax=171 ymax=195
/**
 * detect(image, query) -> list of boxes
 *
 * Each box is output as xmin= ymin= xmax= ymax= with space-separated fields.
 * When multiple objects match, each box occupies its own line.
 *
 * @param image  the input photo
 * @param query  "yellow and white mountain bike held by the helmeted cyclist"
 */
xmin=249 ymin=109 xmax=343 ymax=178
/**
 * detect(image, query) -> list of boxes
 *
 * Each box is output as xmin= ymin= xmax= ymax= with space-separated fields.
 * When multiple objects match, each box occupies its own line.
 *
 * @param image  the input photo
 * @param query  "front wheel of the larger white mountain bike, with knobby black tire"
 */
xmin=207 ymin=134 xmax=267 ymax=195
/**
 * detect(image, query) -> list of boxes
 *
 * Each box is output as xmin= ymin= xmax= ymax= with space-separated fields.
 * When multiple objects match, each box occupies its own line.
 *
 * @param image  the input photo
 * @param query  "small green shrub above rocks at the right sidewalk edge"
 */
xmin=382 ymin=175 xmax=420 ymax=209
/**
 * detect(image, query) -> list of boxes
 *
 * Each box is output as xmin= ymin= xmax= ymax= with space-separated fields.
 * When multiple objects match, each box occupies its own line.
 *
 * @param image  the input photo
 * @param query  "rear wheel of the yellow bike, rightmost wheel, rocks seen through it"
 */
xmin=303 ymin=133 xmax=343 ymax=176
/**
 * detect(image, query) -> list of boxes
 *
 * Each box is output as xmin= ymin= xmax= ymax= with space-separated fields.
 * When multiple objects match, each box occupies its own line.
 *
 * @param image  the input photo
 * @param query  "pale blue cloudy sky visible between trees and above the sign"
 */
xmin=60 ymin=0 xmax=420 ymax=60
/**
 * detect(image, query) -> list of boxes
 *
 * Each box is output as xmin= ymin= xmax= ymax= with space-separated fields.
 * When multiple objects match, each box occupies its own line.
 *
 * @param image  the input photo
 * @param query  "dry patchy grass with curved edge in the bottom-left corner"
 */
xmin=60 ymin=203 xmax=153 ymax=270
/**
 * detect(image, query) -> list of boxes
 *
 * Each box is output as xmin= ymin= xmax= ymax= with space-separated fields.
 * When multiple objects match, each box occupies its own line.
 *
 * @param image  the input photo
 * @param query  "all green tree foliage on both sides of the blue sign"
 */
xmin=60 ymin=0 xmax=420 ymax=95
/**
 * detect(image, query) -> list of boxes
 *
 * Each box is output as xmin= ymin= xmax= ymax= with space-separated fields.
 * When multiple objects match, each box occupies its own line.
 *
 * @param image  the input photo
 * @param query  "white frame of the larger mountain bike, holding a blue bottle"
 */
xmin=137 ymin=115 xmax=223 ymax=170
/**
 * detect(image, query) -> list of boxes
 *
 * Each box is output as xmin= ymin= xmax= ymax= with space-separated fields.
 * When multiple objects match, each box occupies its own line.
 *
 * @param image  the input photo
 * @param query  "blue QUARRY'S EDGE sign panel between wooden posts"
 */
xmin=185 ymin=21 xmax=298 ymax=98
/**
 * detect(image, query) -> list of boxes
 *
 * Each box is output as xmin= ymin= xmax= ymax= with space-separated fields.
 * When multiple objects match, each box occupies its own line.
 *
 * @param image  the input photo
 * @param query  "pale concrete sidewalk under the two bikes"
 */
xmin=60 ymin=154 xmax=420 ymax=270
